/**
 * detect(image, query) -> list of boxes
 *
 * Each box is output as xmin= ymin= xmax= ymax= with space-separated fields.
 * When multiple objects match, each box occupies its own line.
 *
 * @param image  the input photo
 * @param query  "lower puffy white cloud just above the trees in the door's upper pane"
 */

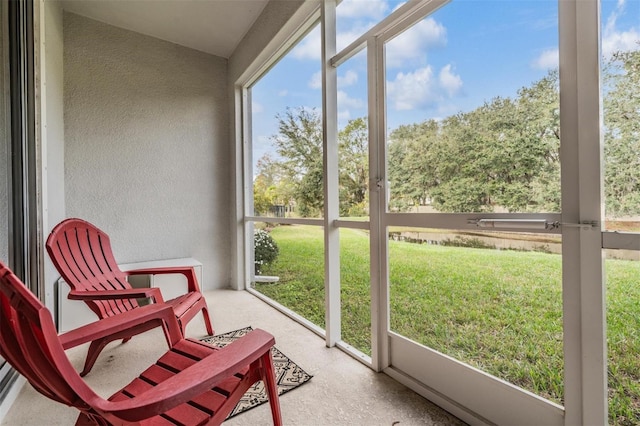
xmin=387 ymin=64 xmax=463 ymax=111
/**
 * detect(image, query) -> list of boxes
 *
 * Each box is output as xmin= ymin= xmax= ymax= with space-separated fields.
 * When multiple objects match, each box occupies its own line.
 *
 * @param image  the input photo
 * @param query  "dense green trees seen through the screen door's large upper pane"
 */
xmin=389 ymin=72 xmax=560 ymax=212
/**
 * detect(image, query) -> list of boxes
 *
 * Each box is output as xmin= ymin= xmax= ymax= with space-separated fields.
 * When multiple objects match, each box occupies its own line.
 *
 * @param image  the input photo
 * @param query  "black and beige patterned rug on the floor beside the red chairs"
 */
xmin=200 ymin=326 xmax=313 ymax=418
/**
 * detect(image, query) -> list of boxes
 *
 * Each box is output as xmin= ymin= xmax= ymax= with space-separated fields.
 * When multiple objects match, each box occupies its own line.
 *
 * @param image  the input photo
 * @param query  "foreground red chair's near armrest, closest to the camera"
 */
xmin=98 ymin=329 xmax=275 ymax=421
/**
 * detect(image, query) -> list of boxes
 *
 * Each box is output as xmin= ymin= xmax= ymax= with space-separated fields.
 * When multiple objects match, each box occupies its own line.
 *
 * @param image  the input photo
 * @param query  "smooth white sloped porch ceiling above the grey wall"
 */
xmin=61 ymin=0 xmax=269 ymax=58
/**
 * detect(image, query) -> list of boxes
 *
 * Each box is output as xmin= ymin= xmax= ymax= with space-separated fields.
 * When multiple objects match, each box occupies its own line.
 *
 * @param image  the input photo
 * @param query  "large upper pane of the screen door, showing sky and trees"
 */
xmin=385 ymin=0 xmax=560 ymax=212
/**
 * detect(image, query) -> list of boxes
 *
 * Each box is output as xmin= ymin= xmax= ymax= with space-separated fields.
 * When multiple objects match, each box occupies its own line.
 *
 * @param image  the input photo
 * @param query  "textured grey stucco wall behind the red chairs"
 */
xmin=64 ymin=13 xmax=234 ymax=288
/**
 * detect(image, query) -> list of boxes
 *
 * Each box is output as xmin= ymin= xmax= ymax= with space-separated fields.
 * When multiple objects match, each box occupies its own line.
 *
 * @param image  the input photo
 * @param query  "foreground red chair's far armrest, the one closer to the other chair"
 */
xmin=58 ymin=303 xmax=182 ymax=350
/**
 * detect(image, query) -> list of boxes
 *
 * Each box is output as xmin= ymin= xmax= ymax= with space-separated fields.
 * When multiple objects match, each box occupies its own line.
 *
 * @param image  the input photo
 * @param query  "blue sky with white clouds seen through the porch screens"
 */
xmin=252 ymin=0 xmax=640 ymax=163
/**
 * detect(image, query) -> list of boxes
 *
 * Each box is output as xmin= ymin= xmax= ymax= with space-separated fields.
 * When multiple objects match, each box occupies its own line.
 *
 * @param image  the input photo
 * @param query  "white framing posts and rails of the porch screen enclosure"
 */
xmin=237 ymin=0 xmax=616 ymax=425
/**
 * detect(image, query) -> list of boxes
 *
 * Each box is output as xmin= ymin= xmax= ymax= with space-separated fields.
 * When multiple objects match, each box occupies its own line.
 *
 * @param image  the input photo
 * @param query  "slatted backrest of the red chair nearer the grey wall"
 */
xmin=46 ymin=218 xmax=138 ymax=318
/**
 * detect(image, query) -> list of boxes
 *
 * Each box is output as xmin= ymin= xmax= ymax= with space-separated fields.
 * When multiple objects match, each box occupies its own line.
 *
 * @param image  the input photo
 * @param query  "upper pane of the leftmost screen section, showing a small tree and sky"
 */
xmin=249 ymin=22 xmax=324 ymax=217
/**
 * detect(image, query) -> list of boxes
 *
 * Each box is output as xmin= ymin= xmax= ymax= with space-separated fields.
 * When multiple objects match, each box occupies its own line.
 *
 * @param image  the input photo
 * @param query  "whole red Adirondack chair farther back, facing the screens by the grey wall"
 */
xmin=46 ymin=218 xmax=213 ymax=376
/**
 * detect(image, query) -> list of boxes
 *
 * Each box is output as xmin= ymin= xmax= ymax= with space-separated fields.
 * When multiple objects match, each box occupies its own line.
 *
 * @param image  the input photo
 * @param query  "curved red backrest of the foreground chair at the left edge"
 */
xmin=0 ymin=262 xmax=95 ymax=412
